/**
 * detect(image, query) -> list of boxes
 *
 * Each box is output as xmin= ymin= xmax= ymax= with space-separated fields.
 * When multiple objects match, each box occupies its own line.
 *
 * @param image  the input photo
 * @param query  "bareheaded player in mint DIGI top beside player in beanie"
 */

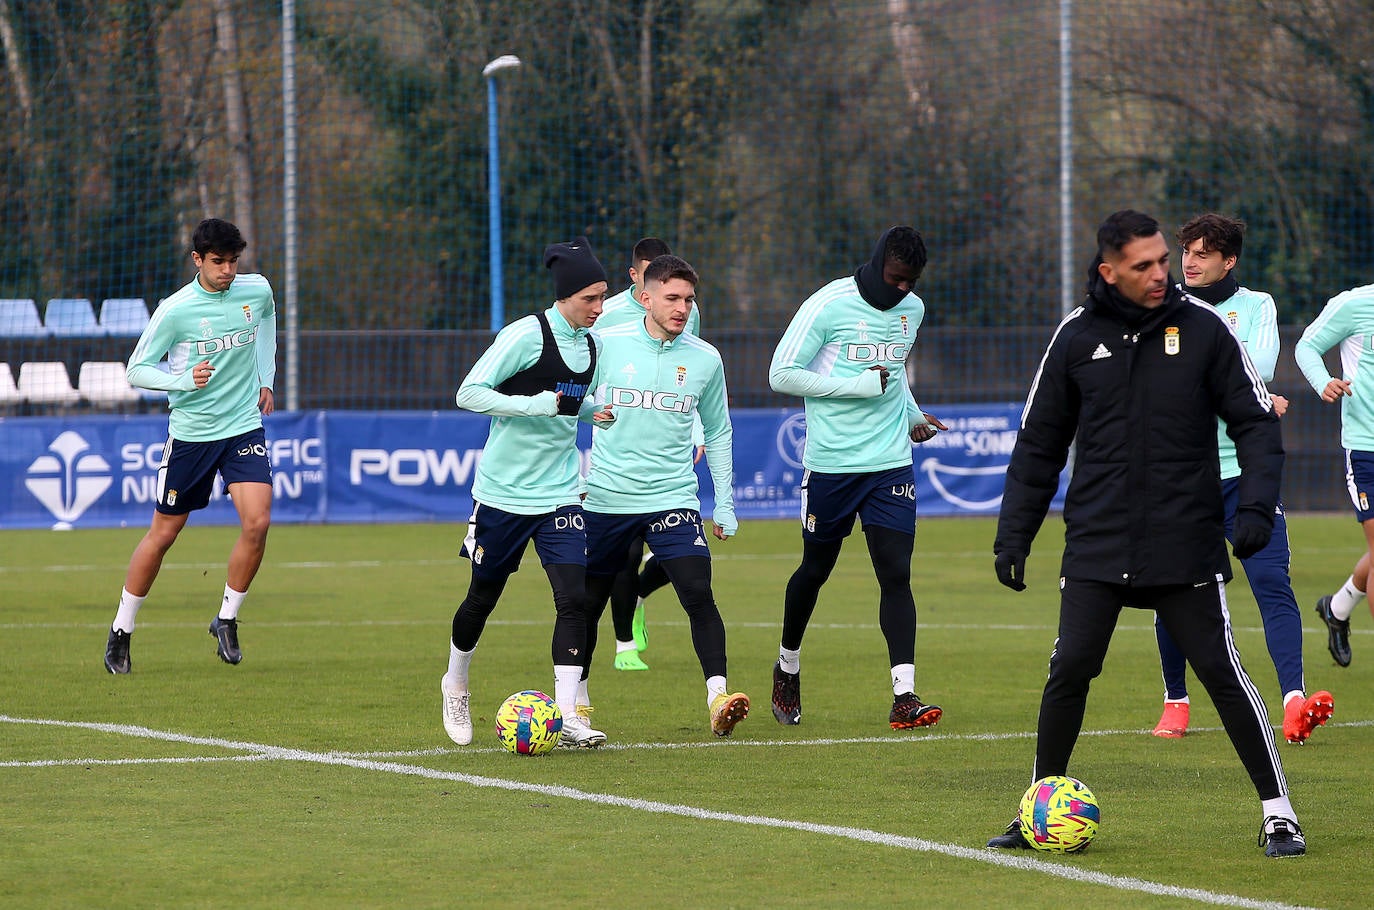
xmin=577 ymin=256 xmax=749 ymax=737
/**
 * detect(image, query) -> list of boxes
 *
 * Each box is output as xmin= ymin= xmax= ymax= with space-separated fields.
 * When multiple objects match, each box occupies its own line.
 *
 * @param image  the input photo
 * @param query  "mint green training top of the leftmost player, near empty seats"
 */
xmin=126 ymin=274 xmax=276 ymax=443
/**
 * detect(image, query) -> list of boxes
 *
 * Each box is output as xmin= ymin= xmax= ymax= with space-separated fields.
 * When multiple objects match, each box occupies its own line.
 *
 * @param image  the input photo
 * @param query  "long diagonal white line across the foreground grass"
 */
xmin=0 ymin=715 xmax=1307 ymax=910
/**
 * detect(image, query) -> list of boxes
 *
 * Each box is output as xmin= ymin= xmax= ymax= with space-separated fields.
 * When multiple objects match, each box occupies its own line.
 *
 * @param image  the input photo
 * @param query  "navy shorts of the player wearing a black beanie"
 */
xmin=460 ymin=503 xmax=588 ymax=577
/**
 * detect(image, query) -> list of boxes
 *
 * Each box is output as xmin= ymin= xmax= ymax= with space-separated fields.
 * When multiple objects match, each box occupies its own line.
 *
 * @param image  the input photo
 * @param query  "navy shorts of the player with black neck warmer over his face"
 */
xmin=801 ymin=467 xmax=916 ymax=543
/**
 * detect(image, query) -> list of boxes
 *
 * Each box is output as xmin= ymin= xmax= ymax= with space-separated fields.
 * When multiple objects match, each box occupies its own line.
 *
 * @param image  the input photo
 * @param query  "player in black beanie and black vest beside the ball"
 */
xmin=440 ymin=236 xmax=610 ymax=748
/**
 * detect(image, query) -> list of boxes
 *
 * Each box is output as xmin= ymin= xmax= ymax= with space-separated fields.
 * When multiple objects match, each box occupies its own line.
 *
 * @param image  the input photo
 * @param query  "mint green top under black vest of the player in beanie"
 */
xmin=456 ymin=307 xmax=600 ymax=515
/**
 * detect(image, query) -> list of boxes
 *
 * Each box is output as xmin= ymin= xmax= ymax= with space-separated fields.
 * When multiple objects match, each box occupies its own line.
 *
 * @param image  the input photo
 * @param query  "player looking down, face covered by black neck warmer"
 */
xmin=768 ymin=225 xmax=945 ymax=730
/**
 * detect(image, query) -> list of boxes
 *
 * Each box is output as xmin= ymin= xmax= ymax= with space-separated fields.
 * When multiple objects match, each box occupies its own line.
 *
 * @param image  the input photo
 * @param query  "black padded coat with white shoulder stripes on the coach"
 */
xmin=993 ymin=278 xmax=1283 ymax=586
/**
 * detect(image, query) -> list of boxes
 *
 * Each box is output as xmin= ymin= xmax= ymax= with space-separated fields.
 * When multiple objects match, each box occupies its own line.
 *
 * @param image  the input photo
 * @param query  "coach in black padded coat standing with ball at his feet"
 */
xmin=988 ymin=210 xmax=1305 ymax=856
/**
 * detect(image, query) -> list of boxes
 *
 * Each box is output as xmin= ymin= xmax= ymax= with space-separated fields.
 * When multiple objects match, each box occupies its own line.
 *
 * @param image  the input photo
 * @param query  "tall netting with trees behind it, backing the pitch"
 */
xmin=0 ymin=0 xmax=1374 ymax=505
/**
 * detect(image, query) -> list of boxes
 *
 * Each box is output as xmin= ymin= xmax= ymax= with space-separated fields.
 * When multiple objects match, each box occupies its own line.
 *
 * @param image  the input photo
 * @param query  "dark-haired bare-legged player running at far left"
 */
xmin=104 ymin=219 xmax=276 ymax=674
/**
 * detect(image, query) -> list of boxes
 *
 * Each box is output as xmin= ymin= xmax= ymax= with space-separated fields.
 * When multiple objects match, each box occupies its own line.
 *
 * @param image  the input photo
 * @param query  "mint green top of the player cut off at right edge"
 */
xmin=1293 ymin=277 xmax=1374 ymax=452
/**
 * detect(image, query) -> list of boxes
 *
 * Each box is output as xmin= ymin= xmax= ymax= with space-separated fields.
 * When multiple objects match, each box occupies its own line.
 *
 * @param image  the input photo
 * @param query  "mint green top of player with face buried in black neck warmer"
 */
xmin=768 ymin=278 xmax=927 ymax=474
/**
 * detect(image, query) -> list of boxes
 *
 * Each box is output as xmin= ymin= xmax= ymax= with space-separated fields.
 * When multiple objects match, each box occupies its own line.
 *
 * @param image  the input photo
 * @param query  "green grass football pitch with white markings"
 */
xmin=0 ymin=515 xmax=1374 ymax=910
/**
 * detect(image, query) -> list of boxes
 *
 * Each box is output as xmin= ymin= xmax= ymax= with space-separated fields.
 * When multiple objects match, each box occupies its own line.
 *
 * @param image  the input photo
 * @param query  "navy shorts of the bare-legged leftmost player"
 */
xmin=155 ymin=426 xmax=272 ymax=515
